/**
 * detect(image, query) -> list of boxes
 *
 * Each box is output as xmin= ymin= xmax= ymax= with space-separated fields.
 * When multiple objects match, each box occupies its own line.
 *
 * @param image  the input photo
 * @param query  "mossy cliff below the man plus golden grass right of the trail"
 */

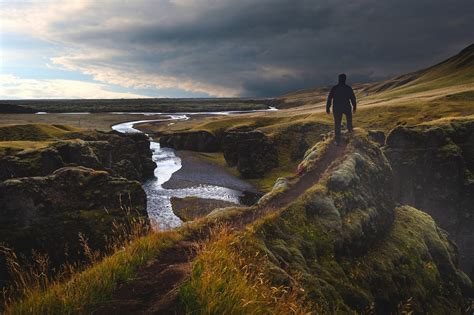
xmin=182 ymin=130 xmax=472 ymax=314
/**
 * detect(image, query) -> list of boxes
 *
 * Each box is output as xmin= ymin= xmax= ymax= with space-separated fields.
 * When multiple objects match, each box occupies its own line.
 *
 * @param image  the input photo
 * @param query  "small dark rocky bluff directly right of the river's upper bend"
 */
xmin=160 ymin=131 xmax=219 ymax=152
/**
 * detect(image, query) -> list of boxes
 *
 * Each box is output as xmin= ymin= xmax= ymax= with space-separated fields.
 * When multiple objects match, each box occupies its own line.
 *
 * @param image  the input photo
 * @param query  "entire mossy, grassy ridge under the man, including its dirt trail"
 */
xmin=7 ymin=129 xmax=472 ymax=314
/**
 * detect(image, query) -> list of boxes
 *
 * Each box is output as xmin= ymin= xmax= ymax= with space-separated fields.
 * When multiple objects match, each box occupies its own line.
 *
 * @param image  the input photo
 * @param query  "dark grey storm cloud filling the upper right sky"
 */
xmin=49 ymin=0 xmax=474 ymax=96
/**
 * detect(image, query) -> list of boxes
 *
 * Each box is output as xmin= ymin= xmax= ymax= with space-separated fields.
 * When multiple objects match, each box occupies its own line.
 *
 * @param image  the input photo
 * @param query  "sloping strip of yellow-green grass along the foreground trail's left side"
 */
xmin=4 ymin=228 xmax=184 ymax=314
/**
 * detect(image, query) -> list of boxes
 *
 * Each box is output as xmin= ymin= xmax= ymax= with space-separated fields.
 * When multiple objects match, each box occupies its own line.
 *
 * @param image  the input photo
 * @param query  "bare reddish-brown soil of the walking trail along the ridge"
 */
xmin=94 ymin=142 xmax=347 ymax=314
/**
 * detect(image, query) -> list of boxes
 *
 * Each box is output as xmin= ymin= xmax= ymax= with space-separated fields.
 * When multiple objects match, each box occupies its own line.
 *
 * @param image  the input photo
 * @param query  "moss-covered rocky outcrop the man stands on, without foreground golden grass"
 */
xmin=246 ymin=130 xmax=472 ymax=314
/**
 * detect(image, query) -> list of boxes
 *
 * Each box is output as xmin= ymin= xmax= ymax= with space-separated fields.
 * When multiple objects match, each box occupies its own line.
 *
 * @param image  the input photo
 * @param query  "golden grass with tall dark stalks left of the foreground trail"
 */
xmin=3 ymin=212 xmax=184 ymax=314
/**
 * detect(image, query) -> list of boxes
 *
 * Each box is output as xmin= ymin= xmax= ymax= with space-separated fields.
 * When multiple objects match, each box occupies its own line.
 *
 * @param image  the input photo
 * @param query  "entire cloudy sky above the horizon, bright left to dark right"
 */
xmin=0 ymin=0 xmax=474 ymax=99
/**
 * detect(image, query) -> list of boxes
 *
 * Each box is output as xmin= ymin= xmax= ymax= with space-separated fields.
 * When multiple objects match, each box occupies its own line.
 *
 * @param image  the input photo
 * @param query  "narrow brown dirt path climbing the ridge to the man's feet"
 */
xmin=91 ymin=131 xmax=346 ymax=314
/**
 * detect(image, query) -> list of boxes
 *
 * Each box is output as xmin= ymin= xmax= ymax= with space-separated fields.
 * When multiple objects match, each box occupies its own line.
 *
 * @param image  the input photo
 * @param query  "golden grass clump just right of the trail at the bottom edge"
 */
xmin=180 ymin=226 xmax=310 ymax=314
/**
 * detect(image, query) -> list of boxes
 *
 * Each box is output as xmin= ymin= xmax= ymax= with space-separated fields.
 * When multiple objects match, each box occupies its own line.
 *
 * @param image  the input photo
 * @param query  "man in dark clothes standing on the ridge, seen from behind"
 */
xmin=326 ymin=73 xmax=357 ymax=145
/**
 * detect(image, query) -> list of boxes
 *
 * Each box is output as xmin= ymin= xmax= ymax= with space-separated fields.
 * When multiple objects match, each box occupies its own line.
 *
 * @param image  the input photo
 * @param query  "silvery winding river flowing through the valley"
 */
xmin=112 ymin=108 xmax=276 ymax=230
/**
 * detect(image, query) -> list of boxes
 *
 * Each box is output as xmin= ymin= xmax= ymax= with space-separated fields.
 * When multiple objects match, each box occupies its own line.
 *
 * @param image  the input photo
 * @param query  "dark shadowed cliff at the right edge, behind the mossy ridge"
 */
xmin=385 ymin=121 xmax=474 ymax=278
